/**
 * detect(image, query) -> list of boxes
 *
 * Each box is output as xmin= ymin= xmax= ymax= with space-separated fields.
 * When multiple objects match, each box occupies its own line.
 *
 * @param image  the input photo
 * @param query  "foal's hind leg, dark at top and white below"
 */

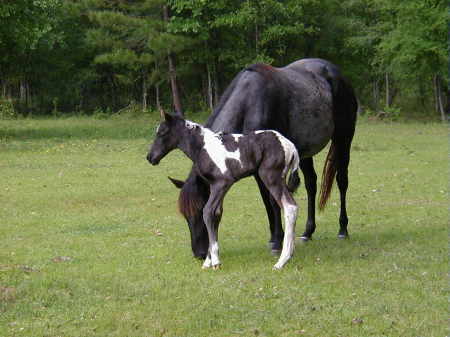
xmin=259 ymin=168 xmax=298 ymax=269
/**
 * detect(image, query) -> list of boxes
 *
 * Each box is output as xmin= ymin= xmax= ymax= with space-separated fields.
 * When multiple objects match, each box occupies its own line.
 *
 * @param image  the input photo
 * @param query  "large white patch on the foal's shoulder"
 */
xmin=202 ymin=127 xmax=242 ymax=174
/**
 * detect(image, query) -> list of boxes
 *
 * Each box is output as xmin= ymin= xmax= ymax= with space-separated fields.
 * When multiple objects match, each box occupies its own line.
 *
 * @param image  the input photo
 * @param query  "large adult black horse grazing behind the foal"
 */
xmin=167 ymin=59 xmax=358 ymax=259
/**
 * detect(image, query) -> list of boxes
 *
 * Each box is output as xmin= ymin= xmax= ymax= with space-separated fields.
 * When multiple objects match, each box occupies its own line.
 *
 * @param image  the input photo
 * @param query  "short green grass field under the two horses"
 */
xmin=0 ymin=118 xmax=448 ymax=337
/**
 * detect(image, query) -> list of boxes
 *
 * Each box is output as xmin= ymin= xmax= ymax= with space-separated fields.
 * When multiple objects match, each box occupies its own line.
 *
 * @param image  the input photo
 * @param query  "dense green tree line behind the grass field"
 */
xmin=0 ymin=0 xmax=448 ymax=119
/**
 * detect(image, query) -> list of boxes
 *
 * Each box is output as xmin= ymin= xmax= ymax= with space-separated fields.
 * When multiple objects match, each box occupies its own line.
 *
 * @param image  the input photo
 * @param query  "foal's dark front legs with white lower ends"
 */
xmin=203 ymin=183 xmax=231 ymax=269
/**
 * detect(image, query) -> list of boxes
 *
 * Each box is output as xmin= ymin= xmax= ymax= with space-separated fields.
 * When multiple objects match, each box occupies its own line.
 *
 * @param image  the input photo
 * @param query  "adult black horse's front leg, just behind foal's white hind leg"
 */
xmin=255 ymin=175 xmax=284 ymax=253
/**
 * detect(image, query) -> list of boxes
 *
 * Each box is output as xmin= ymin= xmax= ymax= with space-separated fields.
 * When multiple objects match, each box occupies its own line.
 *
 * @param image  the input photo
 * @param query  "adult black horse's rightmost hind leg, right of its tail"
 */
xmin=336 ymin=139 xmax=351 ymax=239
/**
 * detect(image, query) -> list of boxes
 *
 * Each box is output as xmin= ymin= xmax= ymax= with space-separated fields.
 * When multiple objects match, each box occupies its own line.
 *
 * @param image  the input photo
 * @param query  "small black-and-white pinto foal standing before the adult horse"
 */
xmin=147 ymin=113 xmax=300 ymax=269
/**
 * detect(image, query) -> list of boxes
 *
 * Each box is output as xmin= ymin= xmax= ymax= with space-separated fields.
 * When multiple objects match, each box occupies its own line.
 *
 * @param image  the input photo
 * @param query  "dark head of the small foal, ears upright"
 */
xmin=147 ymin=112 xmax=186 ymax=165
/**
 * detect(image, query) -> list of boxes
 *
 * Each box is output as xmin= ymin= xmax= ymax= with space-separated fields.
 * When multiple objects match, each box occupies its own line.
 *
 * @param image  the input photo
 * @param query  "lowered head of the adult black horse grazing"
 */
xmin=169 ymin=172 xmax=209 ymax=259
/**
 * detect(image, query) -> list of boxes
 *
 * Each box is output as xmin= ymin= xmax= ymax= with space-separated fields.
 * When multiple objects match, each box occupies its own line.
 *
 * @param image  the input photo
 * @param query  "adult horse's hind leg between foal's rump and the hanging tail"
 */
xmin=300 ymin=157 xmax=317 ymax=241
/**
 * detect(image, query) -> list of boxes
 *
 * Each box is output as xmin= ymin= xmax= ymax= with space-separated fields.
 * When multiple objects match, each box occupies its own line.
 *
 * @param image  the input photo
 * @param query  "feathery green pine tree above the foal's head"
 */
xmin=85 ymin=0 xmax=192 ymax=109
